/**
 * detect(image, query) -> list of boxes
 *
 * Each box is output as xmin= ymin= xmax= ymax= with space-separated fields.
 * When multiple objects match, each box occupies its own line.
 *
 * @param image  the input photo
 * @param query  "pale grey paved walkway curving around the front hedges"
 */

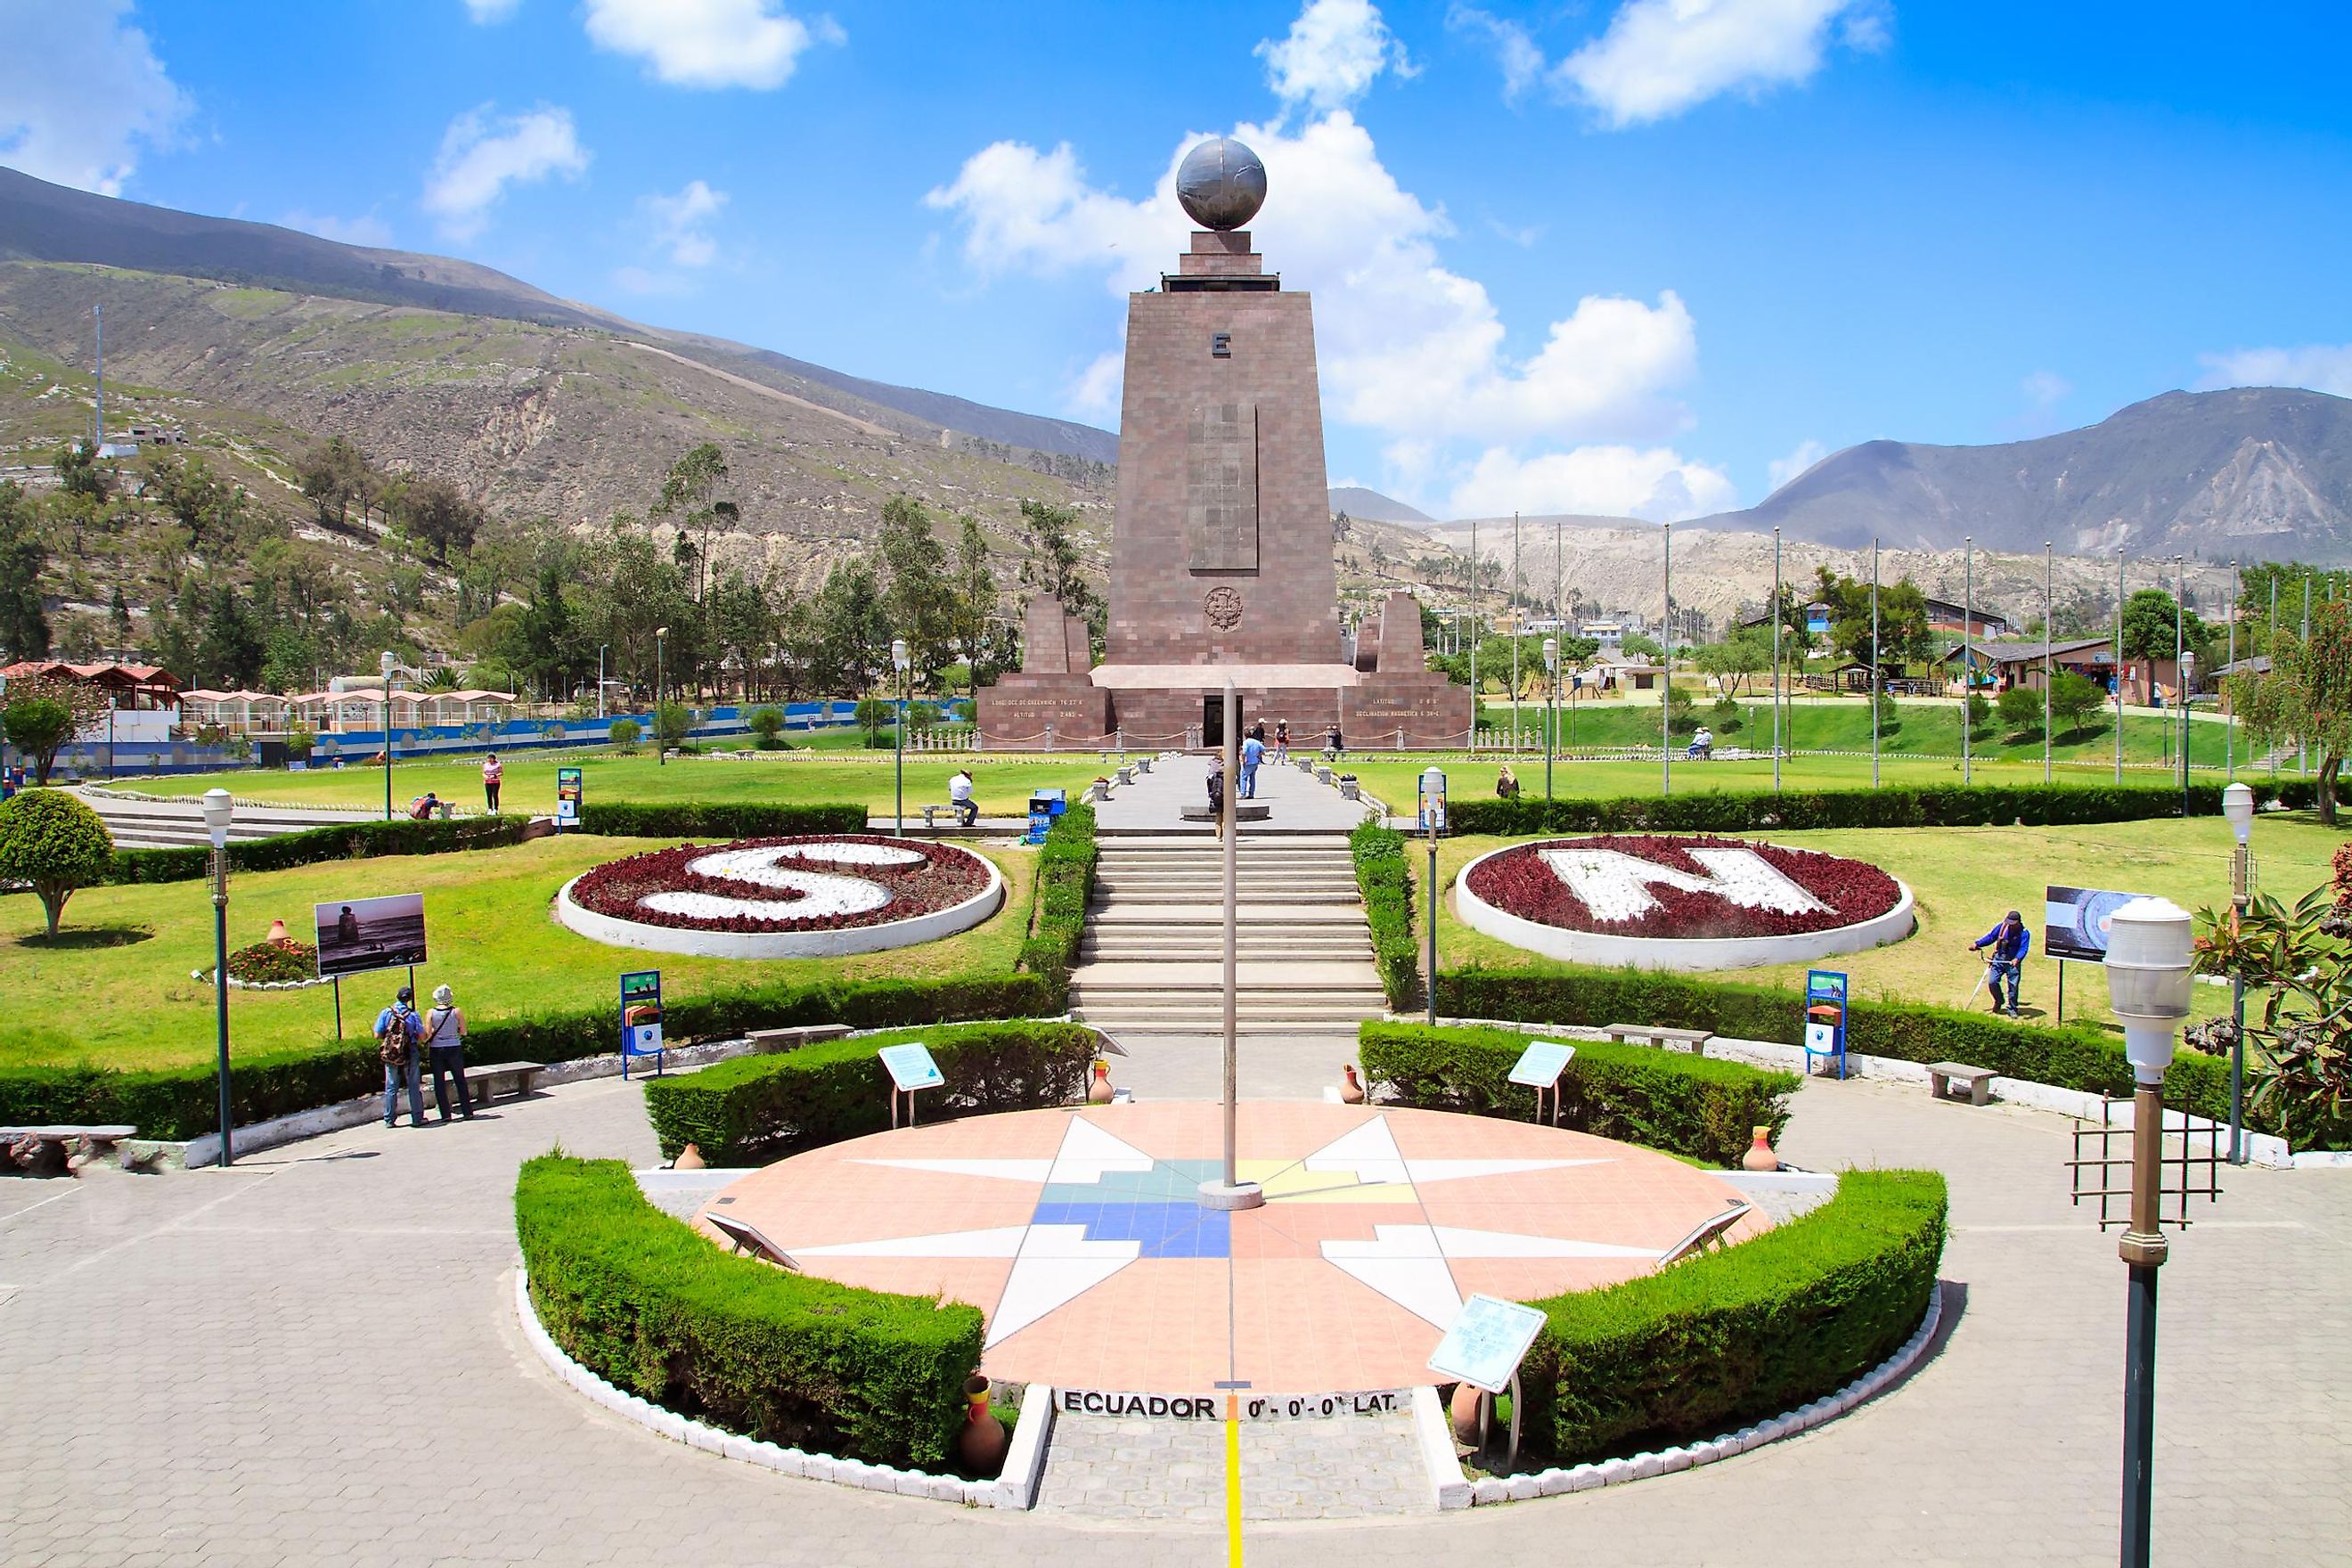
xmin=0 ymin=1062 xmax=2352 ymax=1568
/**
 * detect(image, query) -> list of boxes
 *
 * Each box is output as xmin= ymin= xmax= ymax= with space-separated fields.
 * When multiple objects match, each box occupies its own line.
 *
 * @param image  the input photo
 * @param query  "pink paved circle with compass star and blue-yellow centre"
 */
xmin=713 ymin=1103 xmax=1767 ymax=1394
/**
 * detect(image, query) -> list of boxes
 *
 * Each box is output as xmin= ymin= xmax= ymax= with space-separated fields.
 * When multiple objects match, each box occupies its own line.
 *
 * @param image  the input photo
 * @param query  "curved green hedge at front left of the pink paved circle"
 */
xmin=515 ymin=1155 xmax=981 ymax=1469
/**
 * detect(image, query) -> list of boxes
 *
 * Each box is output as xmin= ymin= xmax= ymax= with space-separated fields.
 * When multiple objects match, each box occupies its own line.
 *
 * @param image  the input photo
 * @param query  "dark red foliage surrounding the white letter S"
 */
xmin=572 ymin=832 xmax=988 ymax=931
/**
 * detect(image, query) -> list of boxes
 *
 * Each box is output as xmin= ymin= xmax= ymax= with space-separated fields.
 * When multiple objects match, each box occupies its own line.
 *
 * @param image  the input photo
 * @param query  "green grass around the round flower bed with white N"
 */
xmin=1407 ymin=811 xmax=2342 ymax=1020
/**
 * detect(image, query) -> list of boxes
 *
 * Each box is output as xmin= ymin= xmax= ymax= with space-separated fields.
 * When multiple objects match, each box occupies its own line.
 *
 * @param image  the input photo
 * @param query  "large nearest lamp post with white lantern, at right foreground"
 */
xmin=2105 ymin=898 xmax=2190 ymax=1568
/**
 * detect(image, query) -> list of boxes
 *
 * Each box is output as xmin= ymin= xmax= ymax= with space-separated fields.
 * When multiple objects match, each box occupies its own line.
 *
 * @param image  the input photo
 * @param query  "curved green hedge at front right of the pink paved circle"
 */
xmin=1519 ymin=1171 xmax=1945 ymax=1465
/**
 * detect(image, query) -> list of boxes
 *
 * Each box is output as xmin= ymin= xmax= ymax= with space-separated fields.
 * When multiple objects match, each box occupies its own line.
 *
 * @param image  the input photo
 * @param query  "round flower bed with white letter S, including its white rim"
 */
xmin=558 ymin=835 xmax=1004 ymax=957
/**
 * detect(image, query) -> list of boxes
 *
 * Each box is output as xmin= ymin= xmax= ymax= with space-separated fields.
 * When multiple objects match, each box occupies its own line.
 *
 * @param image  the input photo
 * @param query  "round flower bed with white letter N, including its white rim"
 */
xmin=1454 ymin=835 xmax=1912 ymax=968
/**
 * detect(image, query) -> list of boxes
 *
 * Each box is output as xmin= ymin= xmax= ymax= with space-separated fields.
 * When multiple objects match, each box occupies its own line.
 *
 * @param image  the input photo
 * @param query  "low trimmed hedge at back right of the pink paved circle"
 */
xmin=1357 ymin=1023 xmax=1797 ymax=1166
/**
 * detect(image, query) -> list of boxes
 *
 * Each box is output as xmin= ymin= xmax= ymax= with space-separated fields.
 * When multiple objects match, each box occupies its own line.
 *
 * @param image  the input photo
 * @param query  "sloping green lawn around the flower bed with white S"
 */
xmin=0 ymin=835 xmax=1033 ymax=1067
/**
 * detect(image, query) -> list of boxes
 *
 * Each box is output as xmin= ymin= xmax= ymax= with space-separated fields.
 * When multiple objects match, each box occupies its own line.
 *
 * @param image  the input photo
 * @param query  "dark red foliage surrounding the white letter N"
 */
xmin=1470 ymin=835 xmax=1903 ymax=938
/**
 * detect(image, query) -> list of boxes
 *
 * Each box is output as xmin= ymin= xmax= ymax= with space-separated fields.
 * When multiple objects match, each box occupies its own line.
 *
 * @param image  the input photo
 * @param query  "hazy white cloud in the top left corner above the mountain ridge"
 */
xmin=0 ymin=0 xmax=192 ymax=195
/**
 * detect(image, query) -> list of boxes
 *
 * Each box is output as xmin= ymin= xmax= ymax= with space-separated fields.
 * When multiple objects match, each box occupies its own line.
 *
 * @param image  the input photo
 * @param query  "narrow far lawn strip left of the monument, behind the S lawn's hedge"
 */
xmin=120 ymin=750 xmax=1103 ymax=821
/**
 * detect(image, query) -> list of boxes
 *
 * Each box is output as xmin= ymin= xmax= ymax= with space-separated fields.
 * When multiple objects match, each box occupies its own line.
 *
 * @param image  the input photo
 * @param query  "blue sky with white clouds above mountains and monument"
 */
xmin=0 ymin=0 xmax=2352 ymax=518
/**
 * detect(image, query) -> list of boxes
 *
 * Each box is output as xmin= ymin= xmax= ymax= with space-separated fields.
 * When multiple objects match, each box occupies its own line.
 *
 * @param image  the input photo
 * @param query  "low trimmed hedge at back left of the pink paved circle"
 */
xmin=644 ymin=1020 xmax=1101 ymax=1166
